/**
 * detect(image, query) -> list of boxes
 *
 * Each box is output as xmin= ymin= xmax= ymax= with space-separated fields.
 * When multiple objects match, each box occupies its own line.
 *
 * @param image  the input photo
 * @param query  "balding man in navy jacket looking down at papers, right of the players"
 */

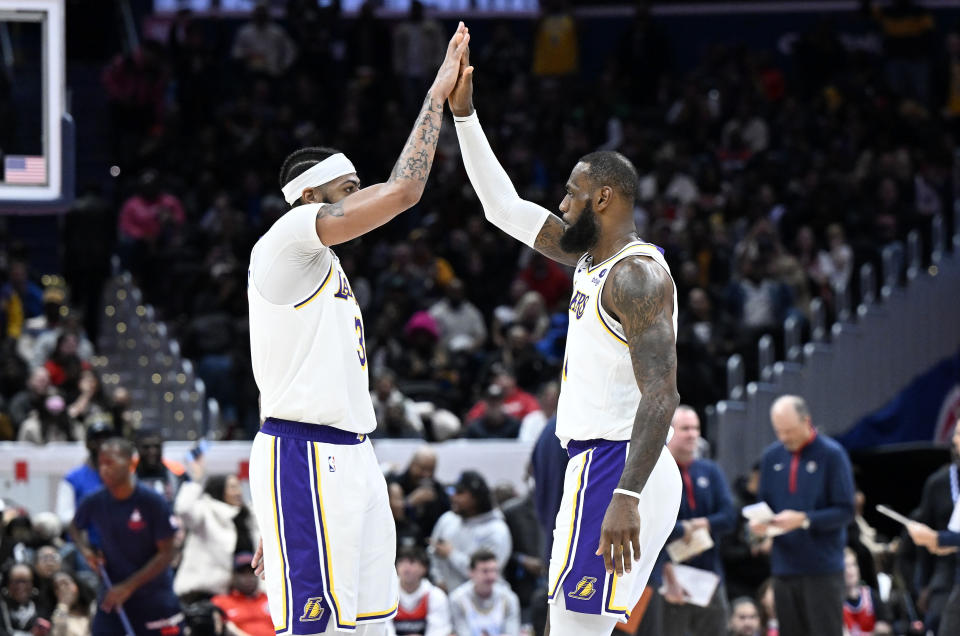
xmin=750 ymin=395 xmax=854 ymax=636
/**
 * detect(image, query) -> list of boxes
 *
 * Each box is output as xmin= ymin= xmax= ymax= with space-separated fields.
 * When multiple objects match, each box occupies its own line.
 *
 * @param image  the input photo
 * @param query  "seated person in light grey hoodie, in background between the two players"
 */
xmin=430 ymin=470 xmax=512 ymax=591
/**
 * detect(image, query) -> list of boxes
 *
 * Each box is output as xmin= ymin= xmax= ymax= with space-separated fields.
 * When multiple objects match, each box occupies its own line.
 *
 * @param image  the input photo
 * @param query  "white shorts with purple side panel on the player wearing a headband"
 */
xmin=250 ymin=418 xmax=399 ymax=636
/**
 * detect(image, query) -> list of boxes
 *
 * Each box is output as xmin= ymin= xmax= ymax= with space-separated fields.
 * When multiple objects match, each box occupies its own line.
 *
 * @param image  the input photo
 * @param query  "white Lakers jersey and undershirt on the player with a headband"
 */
xmin=247 ymin=205 xmax=376 ymax=434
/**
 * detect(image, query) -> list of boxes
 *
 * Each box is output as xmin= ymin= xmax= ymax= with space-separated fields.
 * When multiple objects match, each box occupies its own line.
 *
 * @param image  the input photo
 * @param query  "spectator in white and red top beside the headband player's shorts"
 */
xmin=392 ymin=546 xmax=453 ymax=636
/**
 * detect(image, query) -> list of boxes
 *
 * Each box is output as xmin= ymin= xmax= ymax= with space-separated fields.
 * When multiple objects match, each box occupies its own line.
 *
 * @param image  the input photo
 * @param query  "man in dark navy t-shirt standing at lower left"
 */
xmin=70 ymin=438 xmax=184 ymax=636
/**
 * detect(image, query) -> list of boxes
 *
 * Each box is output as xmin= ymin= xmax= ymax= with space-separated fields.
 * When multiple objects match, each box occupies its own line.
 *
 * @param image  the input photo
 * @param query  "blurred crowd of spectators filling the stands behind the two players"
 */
xmin=0 ymin=0 xmax=960 ymax=634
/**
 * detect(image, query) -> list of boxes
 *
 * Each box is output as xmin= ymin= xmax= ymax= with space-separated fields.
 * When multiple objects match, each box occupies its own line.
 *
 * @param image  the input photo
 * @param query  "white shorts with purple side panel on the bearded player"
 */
xmin=547 ymin=439 xmax=681 ymax=622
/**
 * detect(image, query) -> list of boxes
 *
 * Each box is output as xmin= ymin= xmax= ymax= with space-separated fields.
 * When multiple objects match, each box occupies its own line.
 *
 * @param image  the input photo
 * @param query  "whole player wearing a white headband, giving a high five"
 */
xmin=247 ymin=22 xmax=469 ymax=635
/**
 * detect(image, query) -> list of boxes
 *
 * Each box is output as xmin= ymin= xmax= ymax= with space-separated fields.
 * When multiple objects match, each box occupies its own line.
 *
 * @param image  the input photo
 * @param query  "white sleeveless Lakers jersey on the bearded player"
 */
xmin=557 ymin=241 xmax=677 ymax=448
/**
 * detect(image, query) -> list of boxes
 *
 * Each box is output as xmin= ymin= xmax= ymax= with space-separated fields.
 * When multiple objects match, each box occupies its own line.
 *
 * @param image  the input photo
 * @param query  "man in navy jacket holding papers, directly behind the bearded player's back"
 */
xmin=663 ymin=405 xmax=737 ymax=636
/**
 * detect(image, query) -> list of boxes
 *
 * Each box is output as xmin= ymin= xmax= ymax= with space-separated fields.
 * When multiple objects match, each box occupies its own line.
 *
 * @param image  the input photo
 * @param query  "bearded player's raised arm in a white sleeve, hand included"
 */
xmin=450 ymin=44 xmax=582 ymax=265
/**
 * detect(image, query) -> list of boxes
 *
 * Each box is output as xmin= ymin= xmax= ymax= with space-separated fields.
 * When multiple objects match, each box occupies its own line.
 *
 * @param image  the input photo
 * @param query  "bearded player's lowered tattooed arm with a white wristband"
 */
xmin=597 ymin=256 xmax=680 ymax=574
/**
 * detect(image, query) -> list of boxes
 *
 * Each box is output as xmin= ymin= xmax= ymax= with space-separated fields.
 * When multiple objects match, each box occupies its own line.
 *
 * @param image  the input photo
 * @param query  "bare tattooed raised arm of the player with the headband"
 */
xmin=316 ymin=22 xmax=470 ymax=245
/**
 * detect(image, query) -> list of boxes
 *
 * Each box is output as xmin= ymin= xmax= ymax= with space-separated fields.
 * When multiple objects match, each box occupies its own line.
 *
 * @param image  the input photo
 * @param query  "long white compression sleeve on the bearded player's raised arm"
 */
xmin=453 ymin=111 xmax=550 ymax=247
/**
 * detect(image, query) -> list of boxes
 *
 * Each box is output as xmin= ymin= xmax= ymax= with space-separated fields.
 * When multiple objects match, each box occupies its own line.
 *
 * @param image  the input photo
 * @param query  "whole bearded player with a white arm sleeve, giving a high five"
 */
xmin=450 ymin=51 xmax=681 ymax=636
